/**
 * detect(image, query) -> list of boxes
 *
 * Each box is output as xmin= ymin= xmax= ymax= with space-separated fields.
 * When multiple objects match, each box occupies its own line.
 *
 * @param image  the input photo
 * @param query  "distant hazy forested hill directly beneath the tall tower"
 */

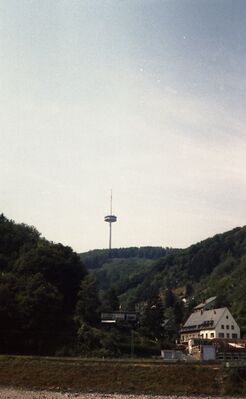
xmin=80 ymin=247 xmax=176 ymax=310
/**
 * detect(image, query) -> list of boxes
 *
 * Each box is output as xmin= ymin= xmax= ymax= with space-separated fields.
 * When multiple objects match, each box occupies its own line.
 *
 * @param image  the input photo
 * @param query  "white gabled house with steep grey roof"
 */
xmin=180 ymin=308 xmax=240 ymax=342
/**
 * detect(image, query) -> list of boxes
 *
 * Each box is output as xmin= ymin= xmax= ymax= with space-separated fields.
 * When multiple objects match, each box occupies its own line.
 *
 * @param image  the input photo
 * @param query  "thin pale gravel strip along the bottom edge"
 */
xmin=0 ymin=387 xmax=245 ymax=399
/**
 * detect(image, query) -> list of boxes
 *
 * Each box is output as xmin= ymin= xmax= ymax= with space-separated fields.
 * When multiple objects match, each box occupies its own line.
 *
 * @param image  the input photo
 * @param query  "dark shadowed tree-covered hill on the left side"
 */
xmin=0 ymin=214 xmax=87 ymax=354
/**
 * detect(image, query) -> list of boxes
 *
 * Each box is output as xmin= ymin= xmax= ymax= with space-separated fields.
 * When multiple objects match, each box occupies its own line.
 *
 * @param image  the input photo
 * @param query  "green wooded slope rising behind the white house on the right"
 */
xmin=136 ymin=227 xmax=246 ymax=325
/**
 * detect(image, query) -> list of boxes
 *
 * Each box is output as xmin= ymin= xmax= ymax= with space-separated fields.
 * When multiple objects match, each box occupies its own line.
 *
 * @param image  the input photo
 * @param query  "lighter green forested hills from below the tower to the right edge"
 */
xmin=82 ymin=226 xmax=246 ymax=328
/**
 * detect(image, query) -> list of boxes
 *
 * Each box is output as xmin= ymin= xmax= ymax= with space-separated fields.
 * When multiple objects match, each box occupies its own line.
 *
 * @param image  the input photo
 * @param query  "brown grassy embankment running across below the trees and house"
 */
xmin=0 ymin=356 xmax=246 ymax=397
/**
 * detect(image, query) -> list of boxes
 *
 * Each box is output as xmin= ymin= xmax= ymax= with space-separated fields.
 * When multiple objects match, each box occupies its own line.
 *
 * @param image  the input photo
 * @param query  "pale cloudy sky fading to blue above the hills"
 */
xmin=0 ymin=0 xmax=246 ymax=252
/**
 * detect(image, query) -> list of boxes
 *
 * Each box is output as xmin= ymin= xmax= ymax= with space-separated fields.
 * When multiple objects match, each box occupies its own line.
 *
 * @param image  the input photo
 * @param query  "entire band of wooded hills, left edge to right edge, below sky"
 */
xmin=0 ymin=215 xmax=246 ymax=357
